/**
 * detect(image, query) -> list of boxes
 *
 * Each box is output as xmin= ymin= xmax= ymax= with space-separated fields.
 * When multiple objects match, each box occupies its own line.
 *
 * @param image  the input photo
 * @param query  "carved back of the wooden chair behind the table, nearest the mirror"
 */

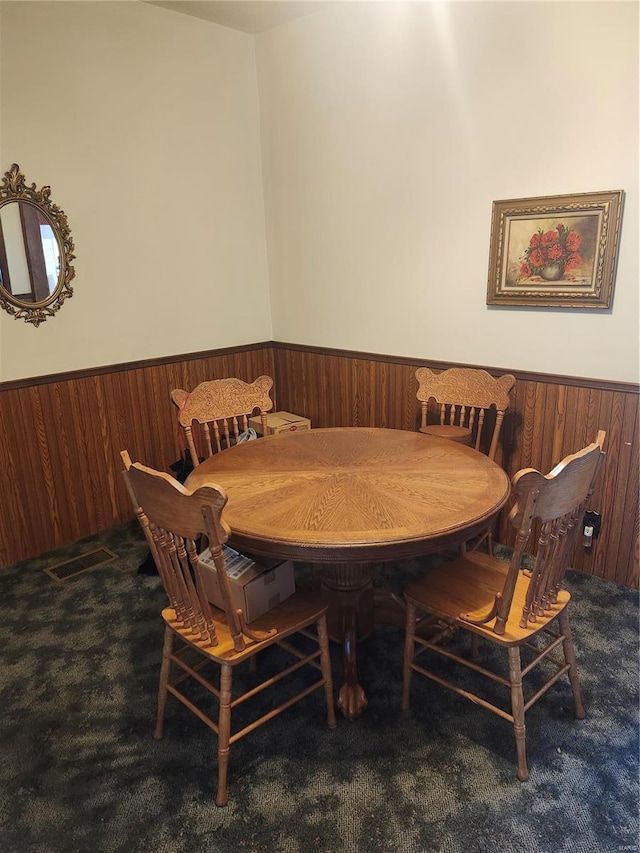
xmin=171 ymin=376 xmax=273 ymax=468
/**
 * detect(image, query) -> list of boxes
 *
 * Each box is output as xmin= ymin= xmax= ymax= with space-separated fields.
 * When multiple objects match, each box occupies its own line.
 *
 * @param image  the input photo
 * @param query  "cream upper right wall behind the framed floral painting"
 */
xmin=256 ymin=2 xmax=639 ymax=381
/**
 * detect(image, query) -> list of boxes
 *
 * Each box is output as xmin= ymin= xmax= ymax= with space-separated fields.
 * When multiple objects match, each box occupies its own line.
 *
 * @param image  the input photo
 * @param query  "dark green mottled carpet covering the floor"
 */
xmin=0 ymin=524 xmax=638 ymax=853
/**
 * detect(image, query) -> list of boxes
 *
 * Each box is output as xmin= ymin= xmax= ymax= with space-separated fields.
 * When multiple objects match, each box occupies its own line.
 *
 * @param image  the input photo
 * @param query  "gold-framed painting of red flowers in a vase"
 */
xmin=487 ymin=190 xmax=624 ymax=308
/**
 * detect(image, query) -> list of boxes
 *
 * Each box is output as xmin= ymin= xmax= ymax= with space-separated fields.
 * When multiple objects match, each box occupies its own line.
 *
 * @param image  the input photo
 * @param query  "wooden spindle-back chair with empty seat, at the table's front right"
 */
xmin=402 ymin=431 xmax=605 ymax=781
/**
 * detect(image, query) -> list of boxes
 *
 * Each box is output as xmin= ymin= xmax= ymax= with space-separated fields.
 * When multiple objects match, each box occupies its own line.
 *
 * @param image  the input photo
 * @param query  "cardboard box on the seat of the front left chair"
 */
xmin=200 ymin=545 xmax=296 ymax=622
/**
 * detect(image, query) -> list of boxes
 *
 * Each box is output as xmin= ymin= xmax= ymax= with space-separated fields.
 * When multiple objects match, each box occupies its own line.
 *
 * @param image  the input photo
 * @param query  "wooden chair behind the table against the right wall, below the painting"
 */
xmin=416 ymin=367 xmax=516 ymax=459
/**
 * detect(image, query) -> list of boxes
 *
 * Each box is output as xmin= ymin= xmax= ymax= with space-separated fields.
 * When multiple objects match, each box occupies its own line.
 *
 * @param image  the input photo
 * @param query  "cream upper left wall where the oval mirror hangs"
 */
xmin=0 ymin=2 xmax=272 ymax=380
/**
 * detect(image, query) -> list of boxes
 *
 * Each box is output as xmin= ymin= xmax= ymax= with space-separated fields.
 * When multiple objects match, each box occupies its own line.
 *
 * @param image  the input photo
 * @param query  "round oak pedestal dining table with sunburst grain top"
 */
xmin=185 ymin=427 xmax=510 ymax=720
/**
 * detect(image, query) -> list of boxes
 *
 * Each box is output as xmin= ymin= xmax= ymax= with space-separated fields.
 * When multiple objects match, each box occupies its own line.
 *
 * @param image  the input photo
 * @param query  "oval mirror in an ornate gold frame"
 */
xmin=0 ymin=163 xmax=75 ymax=326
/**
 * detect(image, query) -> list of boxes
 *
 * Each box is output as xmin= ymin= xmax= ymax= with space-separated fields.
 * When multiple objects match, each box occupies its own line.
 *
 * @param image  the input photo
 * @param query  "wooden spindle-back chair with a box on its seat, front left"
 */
xmin=122 ymin=451 xmax=336 ymax=806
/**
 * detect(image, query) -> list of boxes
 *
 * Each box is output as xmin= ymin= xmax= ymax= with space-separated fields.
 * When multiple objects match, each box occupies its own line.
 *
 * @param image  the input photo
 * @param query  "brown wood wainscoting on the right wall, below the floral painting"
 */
xmin=274 ymin=343 xmax=640 ymax=588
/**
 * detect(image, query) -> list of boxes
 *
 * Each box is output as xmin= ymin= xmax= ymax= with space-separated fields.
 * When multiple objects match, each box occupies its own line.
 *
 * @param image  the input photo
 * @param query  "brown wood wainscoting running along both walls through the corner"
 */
xmin=0 ymin=342 xmax=640 ymax=588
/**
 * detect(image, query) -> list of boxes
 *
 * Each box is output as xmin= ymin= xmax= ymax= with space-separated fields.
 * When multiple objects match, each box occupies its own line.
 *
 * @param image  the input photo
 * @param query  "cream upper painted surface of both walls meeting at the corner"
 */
xmin=0 ymin=0 xmax=639 ymax=381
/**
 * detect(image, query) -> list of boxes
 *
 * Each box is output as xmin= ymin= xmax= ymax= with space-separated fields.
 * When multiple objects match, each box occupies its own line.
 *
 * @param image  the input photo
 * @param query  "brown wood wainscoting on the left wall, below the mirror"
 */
xmin=0 ymin=344 xmax=275 ymax=566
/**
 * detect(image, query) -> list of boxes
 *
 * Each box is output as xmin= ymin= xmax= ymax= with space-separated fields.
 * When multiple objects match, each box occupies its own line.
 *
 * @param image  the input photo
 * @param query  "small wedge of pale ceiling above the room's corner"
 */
xmin=146 ymin=0 xmax=341 ymax=33
